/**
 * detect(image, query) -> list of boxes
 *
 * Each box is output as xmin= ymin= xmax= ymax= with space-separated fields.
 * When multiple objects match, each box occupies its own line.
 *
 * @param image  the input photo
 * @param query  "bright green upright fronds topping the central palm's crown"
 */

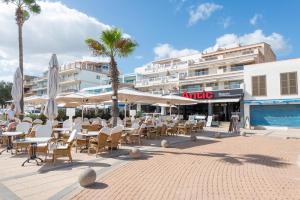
xmin=101 ymin=28 xmax=122 ymax=49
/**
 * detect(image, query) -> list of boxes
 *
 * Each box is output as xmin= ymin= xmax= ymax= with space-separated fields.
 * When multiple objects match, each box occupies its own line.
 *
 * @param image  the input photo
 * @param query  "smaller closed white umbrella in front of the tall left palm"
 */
xmin=11 ymin=67 xmax=23 ymax=114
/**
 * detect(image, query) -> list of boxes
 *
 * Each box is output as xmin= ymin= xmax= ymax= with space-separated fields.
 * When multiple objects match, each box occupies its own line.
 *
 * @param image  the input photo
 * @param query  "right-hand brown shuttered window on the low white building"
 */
xmin=280 ymin=72 xmax=298 ymax=95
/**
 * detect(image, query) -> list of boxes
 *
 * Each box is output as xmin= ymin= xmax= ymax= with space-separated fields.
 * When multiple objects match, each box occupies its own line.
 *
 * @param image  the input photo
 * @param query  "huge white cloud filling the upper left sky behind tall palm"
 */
xmin=0 ymin=1 xmax=110 ymax=81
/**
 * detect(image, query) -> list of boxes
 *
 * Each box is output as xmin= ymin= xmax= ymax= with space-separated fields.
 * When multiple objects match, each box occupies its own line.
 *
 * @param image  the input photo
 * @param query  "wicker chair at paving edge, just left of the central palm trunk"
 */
xmin=88 ymin=127 xmax=110 ymax=154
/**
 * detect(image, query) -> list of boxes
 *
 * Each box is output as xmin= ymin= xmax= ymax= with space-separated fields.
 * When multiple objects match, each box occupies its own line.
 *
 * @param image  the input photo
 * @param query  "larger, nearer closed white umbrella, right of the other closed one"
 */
xmin=44 ymin=54 xmax=59 ymax=120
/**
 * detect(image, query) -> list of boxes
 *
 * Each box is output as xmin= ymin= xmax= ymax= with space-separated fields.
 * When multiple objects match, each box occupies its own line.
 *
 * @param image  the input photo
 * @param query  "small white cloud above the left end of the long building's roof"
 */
xmin=153 ymin=43 xmax=199 ymax=59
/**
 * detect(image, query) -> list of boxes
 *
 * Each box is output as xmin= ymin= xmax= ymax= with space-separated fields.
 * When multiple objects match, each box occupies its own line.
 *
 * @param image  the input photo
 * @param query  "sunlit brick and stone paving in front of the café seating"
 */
xmin=0 ymin=128 xmax=300 ymax=199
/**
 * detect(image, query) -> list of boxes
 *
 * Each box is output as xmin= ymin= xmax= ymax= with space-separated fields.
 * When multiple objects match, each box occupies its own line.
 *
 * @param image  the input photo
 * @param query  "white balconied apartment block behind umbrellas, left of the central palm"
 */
xmin=25 ymin=61 xmax=109 ymax=96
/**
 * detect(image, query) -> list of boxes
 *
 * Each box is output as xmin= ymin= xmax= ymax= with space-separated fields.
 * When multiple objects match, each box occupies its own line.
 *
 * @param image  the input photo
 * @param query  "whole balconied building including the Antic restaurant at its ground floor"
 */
xmin=135 ymin=43 xmax=276 ymax=121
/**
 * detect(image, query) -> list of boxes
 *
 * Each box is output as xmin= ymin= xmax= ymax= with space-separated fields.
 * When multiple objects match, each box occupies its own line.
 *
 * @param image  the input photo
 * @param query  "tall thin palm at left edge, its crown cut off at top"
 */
xmin=3 ymin=0 xmax=41 ymax=113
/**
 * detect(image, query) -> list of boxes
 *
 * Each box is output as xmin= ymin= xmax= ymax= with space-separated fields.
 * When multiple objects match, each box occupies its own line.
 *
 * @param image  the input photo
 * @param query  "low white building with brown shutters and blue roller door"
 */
xmin=244 ymin=58 xmax=300 ymax=128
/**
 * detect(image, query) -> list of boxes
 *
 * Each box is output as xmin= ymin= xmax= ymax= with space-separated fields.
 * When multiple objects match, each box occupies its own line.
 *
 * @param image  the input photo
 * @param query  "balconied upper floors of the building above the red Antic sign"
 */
xmin=135 ymin=43 xmax=276 ymax=94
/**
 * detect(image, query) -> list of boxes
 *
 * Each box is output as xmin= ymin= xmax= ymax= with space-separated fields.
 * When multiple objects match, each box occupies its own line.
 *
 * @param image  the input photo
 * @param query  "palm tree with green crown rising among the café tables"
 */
xmin=85 ymin=28 xmax=137 ymax=126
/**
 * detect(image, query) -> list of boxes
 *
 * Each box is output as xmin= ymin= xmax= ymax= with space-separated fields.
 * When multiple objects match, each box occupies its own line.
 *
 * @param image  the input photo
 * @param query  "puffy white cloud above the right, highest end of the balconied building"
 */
xmin=205 ymin=29 xmax=291 ymax=53
